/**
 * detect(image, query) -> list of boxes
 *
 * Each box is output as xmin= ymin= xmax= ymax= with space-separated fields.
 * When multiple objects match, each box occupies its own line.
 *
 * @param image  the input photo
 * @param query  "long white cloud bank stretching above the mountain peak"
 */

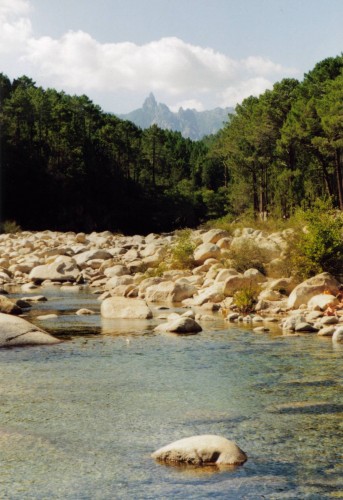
xmin=0 ymin=0 xmax=295 ymax=111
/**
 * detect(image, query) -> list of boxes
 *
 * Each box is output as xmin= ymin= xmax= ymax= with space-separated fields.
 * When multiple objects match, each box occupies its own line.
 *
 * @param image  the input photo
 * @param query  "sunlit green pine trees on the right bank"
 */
xmin=211 ymin=56 xmax=343 ymax=217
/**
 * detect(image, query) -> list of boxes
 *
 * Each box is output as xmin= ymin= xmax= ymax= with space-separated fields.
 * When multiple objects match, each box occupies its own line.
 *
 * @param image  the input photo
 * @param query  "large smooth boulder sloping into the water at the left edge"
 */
xmin=0 ymin=313 xmax=61 ymax=347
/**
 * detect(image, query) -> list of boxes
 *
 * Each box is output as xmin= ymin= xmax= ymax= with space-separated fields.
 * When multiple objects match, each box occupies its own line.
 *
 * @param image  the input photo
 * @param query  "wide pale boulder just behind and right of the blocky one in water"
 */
xmin=145 ymin=281 xmax=197 ymax=302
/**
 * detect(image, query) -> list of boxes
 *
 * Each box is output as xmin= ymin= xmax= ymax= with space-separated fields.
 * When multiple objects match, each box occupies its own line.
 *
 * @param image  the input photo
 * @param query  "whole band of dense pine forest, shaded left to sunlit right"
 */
xmin=0 ymin=56 xmax=343 ymax=234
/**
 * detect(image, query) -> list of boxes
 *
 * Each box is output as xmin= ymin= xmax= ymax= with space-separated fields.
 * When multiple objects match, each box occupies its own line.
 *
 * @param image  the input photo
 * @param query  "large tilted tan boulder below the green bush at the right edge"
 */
xmin=287 ymin=273 xmax=340 ymax=309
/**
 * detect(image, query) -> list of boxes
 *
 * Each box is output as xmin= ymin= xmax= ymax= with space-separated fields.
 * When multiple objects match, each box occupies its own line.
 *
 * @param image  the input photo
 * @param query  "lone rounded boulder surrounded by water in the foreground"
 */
xmin=151 ymin=434 xmax=248 ymax=465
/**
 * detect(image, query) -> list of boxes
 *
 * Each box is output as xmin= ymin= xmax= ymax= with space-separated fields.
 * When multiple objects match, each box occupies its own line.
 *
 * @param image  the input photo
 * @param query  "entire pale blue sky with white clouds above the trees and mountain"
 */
xmin=0 ymin=0 xmax=343 ymax=113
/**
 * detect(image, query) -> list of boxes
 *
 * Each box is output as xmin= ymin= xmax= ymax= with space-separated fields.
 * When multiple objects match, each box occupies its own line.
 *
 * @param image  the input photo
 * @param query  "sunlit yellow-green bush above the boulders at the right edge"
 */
xmin=288 ymin=203 xmax=343 ymax=280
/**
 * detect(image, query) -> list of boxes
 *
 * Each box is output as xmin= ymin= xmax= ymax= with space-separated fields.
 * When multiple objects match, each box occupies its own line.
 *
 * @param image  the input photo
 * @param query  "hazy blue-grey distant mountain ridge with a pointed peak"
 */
xmin=118 ymin=93 xmax=234 ymax=140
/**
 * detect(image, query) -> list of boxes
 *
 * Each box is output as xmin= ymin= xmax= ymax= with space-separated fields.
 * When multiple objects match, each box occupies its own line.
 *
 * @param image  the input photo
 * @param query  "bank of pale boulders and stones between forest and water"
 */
xmin=0 ymin=228 xmax=342 ymax=342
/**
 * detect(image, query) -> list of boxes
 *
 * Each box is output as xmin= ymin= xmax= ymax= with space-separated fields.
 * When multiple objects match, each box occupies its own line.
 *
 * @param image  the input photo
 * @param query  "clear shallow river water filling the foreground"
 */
xmin=0 ymin=290 xmax=343 ymax=500
